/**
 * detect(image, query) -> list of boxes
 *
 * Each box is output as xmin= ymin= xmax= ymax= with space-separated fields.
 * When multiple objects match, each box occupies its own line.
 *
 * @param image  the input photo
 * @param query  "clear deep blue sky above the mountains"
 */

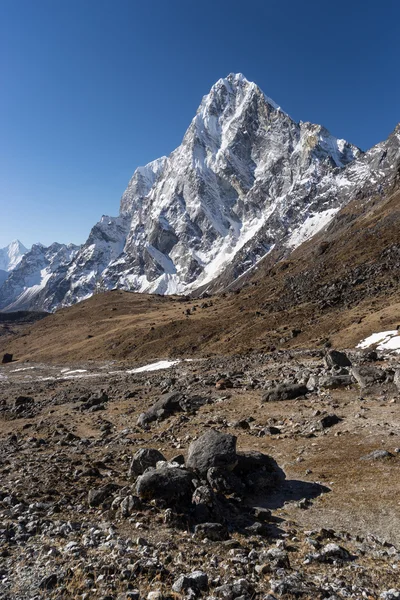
xmin=0 ymin=0 xmax=400 ymax=247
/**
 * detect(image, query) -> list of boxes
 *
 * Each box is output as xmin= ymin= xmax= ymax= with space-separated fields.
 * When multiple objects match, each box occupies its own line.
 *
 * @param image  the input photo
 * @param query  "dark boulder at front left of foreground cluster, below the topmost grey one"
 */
xmin=136 ymin=467 xmax=194 ymax=506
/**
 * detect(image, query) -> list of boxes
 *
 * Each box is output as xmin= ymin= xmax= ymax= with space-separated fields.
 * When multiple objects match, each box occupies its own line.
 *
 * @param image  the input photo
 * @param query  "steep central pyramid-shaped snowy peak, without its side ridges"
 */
xmin=103 ymin=75 xmax=360 ymax=293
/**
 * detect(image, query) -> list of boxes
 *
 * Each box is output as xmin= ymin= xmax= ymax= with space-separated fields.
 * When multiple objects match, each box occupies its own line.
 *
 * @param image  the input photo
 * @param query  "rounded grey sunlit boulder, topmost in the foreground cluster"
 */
xmin=186 ymin=429 xmax=237 ymax=476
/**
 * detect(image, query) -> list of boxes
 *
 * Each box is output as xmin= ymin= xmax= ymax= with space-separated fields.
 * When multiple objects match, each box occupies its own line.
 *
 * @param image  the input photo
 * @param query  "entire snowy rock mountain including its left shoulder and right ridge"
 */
xmin=0 ymin=75 xmax=400 ymax=310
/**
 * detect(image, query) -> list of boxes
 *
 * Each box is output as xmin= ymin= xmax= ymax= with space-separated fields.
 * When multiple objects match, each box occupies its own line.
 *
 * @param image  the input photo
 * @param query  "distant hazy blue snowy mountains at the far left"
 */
xmin=0 ymin=243 xmax=78 ymax=311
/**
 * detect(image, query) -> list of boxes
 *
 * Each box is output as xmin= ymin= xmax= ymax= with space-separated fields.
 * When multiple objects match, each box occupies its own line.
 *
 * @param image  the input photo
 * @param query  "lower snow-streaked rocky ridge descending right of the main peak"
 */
xmin=198 ymin=124 xmax=400 ymax=292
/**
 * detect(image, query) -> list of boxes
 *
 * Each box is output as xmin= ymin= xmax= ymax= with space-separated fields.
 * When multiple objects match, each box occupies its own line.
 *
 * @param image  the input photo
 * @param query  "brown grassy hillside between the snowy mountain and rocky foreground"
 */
xmin=0 ymin=186 xmax=400 ymax=362
